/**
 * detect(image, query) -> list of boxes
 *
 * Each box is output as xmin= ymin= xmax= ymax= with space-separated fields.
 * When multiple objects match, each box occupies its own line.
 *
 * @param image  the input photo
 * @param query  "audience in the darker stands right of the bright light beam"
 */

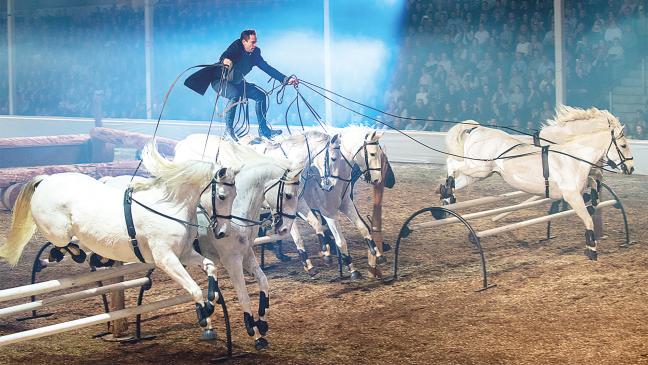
xmin=385 ymin=0 xmax=648 ymax=135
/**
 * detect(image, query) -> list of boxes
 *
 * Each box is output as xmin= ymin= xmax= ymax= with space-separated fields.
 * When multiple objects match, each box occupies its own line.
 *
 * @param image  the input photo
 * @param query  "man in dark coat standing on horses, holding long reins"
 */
xmin=212 ymin=29 xmax=299 ymax=140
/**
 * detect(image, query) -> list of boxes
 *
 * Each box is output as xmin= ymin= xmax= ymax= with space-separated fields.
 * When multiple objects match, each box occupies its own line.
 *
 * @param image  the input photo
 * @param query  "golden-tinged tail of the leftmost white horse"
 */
xmin=0 ymin=175 xmax=47 ymax=266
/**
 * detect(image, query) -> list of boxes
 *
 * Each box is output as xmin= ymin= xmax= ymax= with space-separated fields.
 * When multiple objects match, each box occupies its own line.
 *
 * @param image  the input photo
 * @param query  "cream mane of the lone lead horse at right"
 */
xmin=540 ymin=105 xmax=622 ymax=143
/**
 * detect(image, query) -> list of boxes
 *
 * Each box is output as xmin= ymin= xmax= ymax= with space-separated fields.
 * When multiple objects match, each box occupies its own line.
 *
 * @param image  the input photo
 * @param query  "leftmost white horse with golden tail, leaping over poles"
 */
xmin=0 ymin=142 xmax=238 ymax=327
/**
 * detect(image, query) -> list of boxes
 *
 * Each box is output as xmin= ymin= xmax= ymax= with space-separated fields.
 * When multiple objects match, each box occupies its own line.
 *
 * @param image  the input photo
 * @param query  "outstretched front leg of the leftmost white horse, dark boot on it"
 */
xmin=149 ymin=247 xmax=214 ymax=327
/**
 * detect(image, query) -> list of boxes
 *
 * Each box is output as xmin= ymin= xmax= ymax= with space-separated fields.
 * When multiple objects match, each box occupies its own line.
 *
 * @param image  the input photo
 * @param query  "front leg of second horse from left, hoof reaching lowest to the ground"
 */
xmin=221 ymin=249 xmax=268 ymax=350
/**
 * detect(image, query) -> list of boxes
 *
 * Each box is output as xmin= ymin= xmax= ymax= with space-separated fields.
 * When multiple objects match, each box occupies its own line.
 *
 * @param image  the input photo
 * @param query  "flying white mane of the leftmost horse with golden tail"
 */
xmin=133 ymin=140 xmax=216 ymax=200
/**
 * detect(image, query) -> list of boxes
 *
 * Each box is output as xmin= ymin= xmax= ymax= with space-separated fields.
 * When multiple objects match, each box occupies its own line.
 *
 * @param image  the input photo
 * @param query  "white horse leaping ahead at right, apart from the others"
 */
xmin=442 ymin=107 xmax=634 ymax=260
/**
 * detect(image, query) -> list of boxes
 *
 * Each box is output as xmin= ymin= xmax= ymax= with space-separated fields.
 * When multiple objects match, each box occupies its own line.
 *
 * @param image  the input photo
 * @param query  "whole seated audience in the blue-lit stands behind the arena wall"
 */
xmin=0 ymin=0 xmax=648 ymax=138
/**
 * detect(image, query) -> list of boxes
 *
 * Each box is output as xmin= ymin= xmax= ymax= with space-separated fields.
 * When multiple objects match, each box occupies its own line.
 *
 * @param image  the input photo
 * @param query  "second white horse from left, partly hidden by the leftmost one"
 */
xmin=175 ymin=135 xmax=301 ymax=349
